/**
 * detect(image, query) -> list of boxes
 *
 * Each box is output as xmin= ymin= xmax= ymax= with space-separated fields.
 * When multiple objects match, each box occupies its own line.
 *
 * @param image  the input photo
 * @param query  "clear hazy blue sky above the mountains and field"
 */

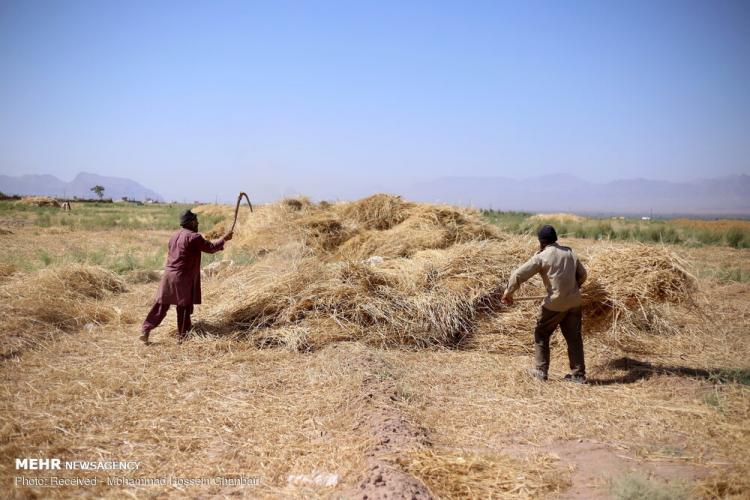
xmin=0 ymin=0 xmax=750 ymax=199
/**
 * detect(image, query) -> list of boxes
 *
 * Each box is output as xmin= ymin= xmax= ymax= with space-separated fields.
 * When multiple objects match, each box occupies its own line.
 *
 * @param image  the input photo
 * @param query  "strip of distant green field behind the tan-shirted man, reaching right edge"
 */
xmin=482 ymin=210 xmax=750 ymax=248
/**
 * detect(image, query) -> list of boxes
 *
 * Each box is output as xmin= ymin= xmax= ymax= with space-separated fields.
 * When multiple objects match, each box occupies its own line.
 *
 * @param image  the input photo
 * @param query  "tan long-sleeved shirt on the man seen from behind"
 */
xmin=506 ymin=243 xmax=586 ymax=311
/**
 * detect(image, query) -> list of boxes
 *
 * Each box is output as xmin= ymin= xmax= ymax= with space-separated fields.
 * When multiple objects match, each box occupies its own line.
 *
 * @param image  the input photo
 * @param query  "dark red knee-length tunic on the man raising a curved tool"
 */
xmin=156 ymin=228 xmax=224 ymax=306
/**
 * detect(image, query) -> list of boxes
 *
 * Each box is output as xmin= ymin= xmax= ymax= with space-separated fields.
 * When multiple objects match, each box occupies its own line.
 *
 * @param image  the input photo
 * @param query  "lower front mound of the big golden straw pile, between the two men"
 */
xmin=201 ymin=241 xmax=518 ymax=346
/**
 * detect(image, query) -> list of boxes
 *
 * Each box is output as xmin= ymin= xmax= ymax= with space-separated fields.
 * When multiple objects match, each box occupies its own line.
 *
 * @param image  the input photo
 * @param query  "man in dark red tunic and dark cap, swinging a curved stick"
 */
xmin=140 ymin=210 xmax=232 ymax=343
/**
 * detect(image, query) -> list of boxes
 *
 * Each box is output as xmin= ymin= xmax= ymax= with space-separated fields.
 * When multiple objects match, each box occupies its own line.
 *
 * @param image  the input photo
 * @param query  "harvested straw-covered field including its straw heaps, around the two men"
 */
xmin=0 ymin=195 xmax=750 ymax=498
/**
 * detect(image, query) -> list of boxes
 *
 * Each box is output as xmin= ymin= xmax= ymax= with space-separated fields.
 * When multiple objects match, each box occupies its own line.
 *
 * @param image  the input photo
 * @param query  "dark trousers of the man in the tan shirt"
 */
xmin=534 ymin=307 xmax=586 ymax=375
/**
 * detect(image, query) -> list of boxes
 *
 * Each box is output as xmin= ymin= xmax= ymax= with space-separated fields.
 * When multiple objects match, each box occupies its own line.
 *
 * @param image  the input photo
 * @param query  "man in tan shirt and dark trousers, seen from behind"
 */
xmin=502 ymin=226 xmax=586 ymax=383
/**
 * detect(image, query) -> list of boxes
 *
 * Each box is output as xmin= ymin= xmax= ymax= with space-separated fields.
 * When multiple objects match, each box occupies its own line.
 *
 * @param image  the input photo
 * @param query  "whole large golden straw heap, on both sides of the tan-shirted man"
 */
xmin=199 ymin=195 xmax=695 ymax=350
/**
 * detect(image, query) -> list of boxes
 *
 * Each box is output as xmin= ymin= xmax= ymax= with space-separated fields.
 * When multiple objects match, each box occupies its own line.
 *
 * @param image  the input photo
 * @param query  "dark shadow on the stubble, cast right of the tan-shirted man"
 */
xmin=588 ymin=357 xmax=750 ymax=385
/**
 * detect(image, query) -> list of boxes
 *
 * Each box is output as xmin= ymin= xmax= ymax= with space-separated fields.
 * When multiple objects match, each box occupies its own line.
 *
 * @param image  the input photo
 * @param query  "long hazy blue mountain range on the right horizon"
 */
xmin=402 ymin=174 xmax=750 ymax=216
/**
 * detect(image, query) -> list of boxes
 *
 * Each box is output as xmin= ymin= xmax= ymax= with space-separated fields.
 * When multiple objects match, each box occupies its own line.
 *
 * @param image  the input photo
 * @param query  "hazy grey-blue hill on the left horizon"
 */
xmin=0 ymin=172 xmax=164 ymax=201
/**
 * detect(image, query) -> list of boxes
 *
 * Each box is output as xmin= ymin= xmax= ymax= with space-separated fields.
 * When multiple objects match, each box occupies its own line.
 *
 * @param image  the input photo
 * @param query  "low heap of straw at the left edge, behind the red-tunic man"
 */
xmin=0 ymin=264 xmax=125 ymax=358
